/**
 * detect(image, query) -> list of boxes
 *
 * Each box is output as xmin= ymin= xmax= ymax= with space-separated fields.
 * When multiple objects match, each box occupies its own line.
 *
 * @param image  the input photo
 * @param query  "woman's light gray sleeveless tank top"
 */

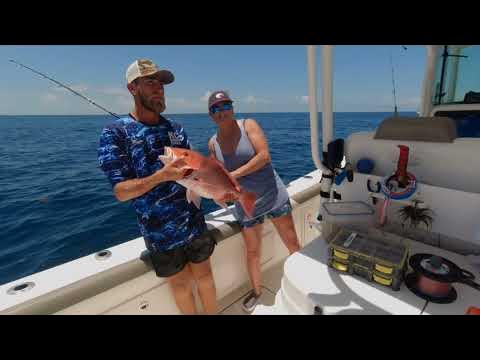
xmin=212 ymin=119 xmax=289 ymax=221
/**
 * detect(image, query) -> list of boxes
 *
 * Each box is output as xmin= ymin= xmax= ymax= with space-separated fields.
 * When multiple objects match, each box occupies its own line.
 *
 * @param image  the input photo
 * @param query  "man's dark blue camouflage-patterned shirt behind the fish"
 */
xmin=98 ymin=117 xmax=206 ymax=251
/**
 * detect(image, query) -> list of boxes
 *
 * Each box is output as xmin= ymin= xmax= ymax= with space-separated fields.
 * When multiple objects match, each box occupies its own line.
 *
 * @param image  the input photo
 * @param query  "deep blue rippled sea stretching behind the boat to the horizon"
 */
xmin=0 ymin=113 xmax=415 ymax=284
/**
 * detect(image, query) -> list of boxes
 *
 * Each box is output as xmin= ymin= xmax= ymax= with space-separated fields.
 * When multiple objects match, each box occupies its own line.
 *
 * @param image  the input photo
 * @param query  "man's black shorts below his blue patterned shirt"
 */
xmin=149 ymin=235 xmax=217 ymax=277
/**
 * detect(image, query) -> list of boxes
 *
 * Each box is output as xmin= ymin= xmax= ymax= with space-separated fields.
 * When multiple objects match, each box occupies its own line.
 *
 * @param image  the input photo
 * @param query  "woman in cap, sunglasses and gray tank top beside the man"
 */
xmin=208 ymin=91 xmax=300 ymax=312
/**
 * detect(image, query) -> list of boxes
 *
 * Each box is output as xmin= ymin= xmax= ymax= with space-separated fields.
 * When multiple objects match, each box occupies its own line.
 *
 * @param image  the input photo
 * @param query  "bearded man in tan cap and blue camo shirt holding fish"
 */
xmin=98 ymin=59 xmax=217 ymax=314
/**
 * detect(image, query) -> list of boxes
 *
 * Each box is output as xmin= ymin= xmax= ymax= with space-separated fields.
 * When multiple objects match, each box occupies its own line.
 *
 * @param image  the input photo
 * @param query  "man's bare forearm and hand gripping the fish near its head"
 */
xmin=113 ymin=157 xmax=187 ymax=201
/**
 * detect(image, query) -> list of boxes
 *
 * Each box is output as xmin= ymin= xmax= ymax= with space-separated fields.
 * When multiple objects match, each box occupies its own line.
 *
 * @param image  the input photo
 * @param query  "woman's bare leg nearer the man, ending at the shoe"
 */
xmin=242 ymin=224 xmax=263 ymax=295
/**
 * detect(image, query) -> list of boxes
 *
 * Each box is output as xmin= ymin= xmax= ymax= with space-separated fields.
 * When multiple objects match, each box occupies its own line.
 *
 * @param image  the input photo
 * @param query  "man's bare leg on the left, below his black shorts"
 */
xmin=167 ymin=264 xmax=197 ymax=315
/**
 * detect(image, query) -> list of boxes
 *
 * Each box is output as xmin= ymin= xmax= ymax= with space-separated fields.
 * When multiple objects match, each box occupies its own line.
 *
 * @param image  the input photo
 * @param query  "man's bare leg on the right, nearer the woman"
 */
xmin=187 ymin=259 xmax=218 ymax=315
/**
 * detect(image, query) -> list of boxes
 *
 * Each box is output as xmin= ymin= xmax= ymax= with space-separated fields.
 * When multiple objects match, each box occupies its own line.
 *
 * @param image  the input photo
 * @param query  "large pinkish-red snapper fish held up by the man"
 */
xmin=159 ymin=146 xmax=257 ymax=217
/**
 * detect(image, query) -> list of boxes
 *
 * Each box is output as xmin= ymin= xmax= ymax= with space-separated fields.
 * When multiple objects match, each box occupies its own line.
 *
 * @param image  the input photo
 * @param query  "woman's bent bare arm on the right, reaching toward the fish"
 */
xmin=230 ymin=119 xmax=272 ymax=179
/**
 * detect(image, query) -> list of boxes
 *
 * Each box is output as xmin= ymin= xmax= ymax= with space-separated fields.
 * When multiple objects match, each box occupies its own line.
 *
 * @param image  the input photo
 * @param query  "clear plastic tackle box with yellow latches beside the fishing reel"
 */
xmin=328 ymin=228 xmax=409 ymax=290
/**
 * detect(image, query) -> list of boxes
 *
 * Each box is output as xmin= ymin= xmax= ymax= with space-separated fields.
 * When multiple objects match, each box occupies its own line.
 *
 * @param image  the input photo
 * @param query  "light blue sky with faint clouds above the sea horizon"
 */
xmin=0 ymin=45 xmax=426 ymax=115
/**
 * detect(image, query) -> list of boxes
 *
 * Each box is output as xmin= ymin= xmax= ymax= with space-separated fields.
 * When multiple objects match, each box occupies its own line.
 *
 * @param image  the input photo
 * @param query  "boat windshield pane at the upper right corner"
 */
xmin=433 ymin=45 xmax=480 ymax=105
